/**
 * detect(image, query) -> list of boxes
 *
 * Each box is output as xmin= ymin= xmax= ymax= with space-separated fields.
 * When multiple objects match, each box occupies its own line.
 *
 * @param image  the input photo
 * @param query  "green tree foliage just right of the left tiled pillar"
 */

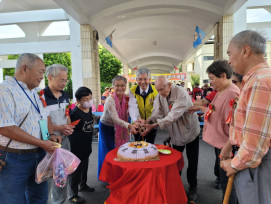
xmin=99 ymin=46 xmax=122 ymax=84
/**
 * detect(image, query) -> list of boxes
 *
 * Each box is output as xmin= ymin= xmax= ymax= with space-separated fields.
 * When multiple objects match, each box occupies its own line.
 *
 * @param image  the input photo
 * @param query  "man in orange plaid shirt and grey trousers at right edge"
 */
xmin=221 ymin=30 xmax=271 ymax=204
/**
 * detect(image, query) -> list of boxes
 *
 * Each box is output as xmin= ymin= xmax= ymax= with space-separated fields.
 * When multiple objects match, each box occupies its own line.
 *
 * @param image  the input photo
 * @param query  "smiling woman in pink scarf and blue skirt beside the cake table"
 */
xmin=98 ymin=76 xmax=137 ymax=178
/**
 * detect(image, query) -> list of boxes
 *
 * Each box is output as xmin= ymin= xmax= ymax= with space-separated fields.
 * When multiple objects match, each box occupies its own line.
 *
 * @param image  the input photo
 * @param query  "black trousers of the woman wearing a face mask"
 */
xmin=69 ymin=158 xmax=89 ymax=198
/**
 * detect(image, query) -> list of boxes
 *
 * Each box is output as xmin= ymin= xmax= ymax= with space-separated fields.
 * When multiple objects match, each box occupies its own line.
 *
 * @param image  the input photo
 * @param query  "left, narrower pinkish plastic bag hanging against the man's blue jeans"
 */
xmin=35 ymin=153 xmax=55 ymax=183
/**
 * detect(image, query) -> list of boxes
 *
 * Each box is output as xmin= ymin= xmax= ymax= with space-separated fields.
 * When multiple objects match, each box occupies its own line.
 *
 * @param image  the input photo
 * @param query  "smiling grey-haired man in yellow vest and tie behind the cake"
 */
xmin=129 ymin=68 xmax=158 ymax=144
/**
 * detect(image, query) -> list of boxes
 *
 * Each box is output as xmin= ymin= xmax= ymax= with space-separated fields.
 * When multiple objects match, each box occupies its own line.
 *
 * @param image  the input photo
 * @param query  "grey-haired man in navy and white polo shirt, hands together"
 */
xmin=44 ymin=64 xmax=74 ymax=204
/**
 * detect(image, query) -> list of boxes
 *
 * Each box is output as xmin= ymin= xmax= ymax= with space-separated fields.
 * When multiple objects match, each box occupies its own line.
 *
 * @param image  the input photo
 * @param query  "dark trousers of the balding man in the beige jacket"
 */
xmin=173 ymin=136 xmax=199 ymax=188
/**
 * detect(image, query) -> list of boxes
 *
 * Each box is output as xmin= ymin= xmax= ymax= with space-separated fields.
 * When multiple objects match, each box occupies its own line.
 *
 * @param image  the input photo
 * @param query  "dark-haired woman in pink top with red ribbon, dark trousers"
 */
xmin=203 ymin=60 xmax=240 ymax=204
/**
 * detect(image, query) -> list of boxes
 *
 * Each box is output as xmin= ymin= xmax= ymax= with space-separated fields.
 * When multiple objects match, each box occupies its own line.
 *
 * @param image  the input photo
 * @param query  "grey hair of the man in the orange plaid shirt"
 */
xmin=231 ymin=30 xmax=266 ymax=54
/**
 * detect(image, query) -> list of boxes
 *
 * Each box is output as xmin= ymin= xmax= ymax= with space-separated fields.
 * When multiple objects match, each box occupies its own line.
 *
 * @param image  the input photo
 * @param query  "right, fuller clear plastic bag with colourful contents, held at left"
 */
xmin=53 ymin=148 xmax=81 ymax=188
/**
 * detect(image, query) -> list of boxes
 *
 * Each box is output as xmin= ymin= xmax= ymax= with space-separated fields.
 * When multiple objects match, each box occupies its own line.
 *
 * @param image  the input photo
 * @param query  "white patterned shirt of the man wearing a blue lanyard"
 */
xmin=0 ymin=76 xmax=48 ymax=149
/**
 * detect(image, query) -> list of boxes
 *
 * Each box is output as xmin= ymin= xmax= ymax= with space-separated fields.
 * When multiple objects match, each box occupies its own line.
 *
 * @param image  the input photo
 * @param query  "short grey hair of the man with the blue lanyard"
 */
xmin=15 ymin=53 xmax=42 ymax=71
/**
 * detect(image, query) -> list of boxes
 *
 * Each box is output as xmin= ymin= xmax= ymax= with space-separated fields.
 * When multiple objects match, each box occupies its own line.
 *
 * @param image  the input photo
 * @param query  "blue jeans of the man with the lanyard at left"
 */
xmin=0 ymin=149 xmax=48 ymax=204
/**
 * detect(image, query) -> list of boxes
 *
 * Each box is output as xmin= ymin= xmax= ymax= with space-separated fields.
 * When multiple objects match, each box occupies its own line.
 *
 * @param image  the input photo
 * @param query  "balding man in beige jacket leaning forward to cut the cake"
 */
xmin=143 ymin=76 xmax=200 ymax=202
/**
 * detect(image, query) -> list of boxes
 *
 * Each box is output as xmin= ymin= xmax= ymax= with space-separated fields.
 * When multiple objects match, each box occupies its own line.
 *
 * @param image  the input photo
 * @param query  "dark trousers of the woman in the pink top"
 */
xmin=215 ymin=148 xmax=238 ymax=204
